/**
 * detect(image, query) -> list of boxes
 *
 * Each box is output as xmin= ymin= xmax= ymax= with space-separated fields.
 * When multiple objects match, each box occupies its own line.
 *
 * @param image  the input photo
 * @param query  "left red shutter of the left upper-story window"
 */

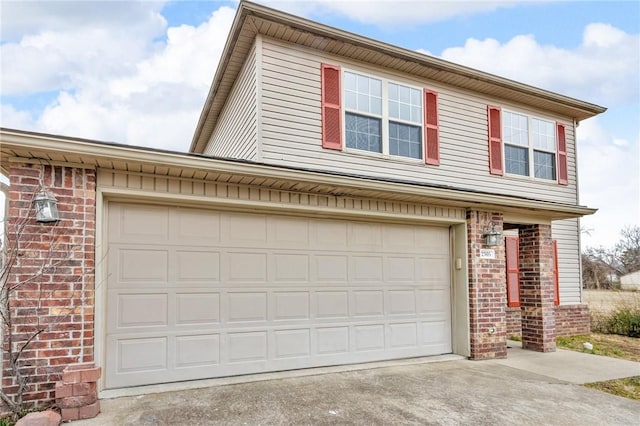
xmin=320 ymin=64 xmax=342 ymax=149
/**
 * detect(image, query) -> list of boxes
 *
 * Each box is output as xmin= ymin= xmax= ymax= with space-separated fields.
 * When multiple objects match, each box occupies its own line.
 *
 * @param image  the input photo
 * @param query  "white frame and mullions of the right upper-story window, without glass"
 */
xmin=500 ymin=109 xmax=558 ymax=183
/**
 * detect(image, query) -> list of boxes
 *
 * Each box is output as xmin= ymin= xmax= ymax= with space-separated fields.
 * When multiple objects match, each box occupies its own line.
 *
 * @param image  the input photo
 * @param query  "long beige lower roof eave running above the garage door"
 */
xmin=0 ymin=129 xmax=597 ymax=220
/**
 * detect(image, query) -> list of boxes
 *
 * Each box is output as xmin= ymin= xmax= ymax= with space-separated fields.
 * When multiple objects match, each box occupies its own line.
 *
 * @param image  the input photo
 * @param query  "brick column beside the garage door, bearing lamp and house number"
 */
xmin=467 ymin=210 xmax=507 ymax=359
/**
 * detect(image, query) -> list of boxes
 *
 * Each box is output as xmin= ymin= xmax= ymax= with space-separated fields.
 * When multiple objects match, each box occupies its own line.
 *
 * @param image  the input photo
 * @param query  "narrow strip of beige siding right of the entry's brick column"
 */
xmin=551 ymin=219 xmax=581 ymax=305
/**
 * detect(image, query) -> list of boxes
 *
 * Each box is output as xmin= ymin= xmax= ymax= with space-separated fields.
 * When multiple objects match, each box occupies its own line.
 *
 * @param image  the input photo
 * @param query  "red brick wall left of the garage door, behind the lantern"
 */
xmin=2 ymin=163 xmax=96 ymax=405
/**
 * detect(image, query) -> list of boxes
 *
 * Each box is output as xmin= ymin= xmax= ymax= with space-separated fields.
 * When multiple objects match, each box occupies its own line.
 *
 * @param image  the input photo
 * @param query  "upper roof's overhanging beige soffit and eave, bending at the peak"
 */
xmin=190 ymin=2 xmax=606 ymax=153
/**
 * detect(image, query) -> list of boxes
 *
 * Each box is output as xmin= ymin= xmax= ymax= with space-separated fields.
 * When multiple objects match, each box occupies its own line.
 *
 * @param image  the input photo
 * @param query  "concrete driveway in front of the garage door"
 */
xmin=74 ymin=348 xmax=640 ymax=426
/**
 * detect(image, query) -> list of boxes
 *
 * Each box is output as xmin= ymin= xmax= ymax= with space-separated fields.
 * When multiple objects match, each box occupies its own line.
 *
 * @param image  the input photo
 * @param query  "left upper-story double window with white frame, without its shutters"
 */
xmin=344 ymin=71 xmax=423 ymax=159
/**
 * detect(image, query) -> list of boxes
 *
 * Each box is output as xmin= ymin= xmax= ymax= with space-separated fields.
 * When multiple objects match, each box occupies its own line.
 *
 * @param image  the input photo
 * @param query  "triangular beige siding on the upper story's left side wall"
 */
xmin=204 ymin=45 xmax=259 ymax=160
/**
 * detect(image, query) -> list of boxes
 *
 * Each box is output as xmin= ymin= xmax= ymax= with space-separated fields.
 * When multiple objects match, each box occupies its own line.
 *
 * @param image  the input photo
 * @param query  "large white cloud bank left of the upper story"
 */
xmin=0 ymin=7 xmax=235 ymax=150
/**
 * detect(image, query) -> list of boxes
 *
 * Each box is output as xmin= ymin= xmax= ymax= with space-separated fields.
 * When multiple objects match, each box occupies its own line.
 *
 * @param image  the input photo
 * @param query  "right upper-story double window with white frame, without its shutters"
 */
xmin=502 ymin=111 xmax=556 ymax=180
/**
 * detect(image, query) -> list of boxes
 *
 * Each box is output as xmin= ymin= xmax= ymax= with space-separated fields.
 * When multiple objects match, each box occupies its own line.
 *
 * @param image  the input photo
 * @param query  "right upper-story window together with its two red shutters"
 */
xmin=488 ymin=106 xmax=568 ymax=185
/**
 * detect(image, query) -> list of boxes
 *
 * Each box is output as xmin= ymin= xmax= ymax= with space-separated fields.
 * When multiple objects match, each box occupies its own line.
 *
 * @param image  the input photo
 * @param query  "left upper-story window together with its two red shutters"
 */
xmin=321 ymin=64 xmax=440 ymax=165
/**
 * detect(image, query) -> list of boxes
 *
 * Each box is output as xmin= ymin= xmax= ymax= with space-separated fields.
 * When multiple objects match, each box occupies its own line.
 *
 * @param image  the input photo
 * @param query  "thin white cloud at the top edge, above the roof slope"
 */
xmin=259 ymin=0 xmax=517 ymax=27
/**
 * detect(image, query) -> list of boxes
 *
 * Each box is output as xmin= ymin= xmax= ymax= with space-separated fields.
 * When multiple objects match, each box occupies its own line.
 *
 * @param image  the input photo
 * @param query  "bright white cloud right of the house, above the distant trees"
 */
xmin=577 ymin=117 xmax=640 ymax=247
